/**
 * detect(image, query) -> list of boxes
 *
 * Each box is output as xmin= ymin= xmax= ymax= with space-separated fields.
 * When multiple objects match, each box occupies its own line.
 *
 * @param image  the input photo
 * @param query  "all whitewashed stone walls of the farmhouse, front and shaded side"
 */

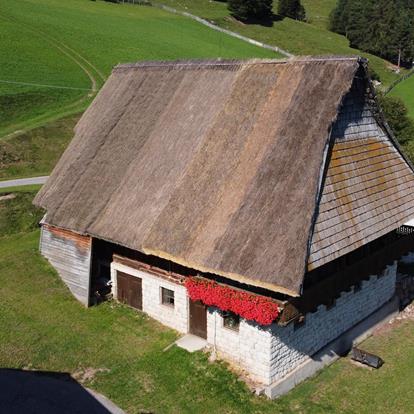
xmin=111 ymin=262 xmax=397 ymax=385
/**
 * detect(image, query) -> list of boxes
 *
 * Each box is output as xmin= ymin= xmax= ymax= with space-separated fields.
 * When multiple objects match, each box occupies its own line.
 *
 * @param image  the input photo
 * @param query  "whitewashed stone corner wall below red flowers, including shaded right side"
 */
xmin=207 ymin=263 xmax=396 ymax=385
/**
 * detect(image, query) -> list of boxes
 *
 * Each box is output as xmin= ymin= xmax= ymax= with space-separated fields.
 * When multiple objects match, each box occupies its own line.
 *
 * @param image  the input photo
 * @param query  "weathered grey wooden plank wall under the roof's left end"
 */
xmin=40 ymin=224 xmax=92 ymax=306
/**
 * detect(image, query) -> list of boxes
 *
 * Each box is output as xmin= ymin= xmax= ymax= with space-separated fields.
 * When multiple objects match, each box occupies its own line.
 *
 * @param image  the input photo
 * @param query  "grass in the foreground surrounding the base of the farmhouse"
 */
xmin=0 ymin=192 xmax=414 ymax=414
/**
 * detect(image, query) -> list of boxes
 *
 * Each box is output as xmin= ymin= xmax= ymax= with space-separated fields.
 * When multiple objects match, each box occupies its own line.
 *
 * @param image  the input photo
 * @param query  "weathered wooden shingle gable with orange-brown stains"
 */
xmin=309 ymin=78 xmax=414 ymax=270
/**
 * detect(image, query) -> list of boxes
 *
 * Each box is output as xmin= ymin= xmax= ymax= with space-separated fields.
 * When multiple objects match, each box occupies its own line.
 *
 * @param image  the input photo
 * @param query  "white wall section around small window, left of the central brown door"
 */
xmin=111 ymin=262 xmax=188 ymax=333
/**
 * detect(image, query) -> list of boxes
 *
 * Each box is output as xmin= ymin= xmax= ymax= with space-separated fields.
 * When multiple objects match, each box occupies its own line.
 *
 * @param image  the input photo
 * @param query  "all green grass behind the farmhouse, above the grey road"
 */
xmin=0 ymin=0 xmax=404 ymax=179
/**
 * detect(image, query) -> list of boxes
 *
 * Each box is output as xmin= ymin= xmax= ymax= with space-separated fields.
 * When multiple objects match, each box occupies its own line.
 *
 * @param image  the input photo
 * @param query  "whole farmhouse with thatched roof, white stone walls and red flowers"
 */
xmin=35 ymin=57 xmax=414 ymax=396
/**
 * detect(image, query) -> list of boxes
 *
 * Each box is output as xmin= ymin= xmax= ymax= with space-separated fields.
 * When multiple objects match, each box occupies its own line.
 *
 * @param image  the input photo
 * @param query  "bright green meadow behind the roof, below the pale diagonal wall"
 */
xmin=0 ymin=0 xmax=276 ymax=136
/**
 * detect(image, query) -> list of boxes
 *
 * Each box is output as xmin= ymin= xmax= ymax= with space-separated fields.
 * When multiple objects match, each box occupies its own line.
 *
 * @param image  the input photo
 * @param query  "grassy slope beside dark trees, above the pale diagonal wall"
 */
xmin=162 ymin=0 xmax=397 ymax=84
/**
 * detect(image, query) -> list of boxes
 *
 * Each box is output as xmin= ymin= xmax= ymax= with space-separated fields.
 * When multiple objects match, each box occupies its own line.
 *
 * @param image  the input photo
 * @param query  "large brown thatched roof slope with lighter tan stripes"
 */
xmin=35 ymin=58 xmax=410 ymax=295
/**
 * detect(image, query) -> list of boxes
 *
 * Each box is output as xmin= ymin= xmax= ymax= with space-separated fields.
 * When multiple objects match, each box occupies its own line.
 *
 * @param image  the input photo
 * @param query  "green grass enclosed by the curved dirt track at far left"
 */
xmin=0 ymin=14 xmax=90 ymax=136
